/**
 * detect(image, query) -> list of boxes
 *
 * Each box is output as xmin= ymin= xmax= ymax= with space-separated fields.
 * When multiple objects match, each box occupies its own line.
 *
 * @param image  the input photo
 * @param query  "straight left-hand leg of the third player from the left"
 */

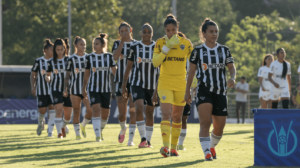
xmin=71 ymin=95 xmax=81 ymax=140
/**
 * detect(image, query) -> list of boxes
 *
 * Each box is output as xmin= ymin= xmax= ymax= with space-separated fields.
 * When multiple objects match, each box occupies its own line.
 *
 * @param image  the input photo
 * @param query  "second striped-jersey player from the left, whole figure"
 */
xmin=46 ymin=38 xmax=72 ymax=139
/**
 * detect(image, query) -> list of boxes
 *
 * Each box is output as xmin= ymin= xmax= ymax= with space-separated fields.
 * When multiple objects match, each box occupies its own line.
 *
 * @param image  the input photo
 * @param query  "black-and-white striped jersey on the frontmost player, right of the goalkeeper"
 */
xmin=190 ymin=43 xmax=234 ymax=95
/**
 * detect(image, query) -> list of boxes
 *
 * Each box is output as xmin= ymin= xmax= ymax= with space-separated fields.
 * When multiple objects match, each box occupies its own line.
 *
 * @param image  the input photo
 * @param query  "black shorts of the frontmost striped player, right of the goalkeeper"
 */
xmin=196 ymin=85 xmax=228 ymax=116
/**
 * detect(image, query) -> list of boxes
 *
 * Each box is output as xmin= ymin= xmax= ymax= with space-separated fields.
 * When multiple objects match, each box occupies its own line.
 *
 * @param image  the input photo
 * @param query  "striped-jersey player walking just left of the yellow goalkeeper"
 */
xmin=122 ymin=23 xmax=158 ymax=148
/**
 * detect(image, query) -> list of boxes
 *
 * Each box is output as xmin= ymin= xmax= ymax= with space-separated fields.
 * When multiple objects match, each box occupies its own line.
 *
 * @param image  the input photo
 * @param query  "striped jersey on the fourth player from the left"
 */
xmin=85 ymin=53 xmax=116 ymax=93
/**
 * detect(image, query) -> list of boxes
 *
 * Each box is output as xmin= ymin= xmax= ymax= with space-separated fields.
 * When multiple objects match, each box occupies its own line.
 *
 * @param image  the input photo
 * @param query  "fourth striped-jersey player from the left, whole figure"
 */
xmin=82 ymin=33 xmax=116 ymax=142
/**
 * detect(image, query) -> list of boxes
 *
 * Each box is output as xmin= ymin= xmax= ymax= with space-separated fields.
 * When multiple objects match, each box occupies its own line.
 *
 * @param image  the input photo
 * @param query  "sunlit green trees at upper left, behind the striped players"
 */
xmin=2 ymin=0 xmax=122 ymax=65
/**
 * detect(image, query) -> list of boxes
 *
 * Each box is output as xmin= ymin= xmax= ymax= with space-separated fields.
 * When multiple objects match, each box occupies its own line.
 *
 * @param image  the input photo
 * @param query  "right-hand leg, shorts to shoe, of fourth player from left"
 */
xmin=100 ymin=93 xmax=111 ymax=140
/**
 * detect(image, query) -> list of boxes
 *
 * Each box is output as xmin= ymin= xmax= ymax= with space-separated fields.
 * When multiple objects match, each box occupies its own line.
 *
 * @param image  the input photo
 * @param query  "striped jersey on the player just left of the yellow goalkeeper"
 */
xmin=127 ymin=41 xmax=159 ymax=90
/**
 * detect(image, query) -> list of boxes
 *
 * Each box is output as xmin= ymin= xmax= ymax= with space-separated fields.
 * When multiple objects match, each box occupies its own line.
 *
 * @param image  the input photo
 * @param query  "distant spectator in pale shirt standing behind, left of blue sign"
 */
xmin=235 ymin=76 xmax=249 ymax=123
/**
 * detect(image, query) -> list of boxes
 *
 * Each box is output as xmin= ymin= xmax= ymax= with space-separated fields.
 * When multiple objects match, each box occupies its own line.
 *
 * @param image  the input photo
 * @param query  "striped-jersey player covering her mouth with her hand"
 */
xmin=112 ymin=22 xmax=136 ymax=146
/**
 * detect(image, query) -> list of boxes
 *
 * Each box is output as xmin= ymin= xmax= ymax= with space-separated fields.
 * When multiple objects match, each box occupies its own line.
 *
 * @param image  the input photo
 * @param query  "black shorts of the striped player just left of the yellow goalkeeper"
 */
xmin=131 ymin=86 xmax=158 ymax=106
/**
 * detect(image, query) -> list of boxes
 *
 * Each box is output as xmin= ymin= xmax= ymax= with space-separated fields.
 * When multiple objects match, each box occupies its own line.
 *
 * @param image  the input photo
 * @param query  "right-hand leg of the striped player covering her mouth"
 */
xmin=127 ymin=97 xmax=136 ymax=146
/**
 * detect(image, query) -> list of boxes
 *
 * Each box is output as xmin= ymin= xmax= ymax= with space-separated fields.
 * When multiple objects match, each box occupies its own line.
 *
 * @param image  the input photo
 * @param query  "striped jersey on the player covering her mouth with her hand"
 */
xmin=112 ymin=40 xmax=137 ymax=83
